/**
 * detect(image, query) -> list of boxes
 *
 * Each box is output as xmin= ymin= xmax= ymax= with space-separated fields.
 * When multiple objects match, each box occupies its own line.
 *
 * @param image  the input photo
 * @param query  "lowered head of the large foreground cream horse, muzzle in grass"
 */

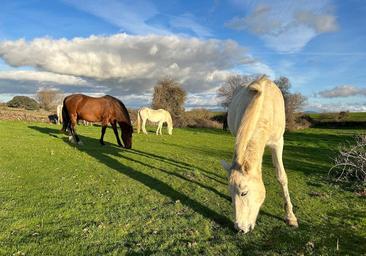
xmin=221 ymin=161 xmax=266 ymax=233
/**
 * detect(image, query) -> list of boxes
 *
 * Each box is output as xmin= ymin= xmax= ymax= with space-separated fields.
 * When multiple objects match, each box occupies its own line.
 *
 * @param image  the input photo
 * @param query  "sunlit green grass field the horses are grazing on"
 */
xmin=0 ymin=121 xmax=366 ymax=255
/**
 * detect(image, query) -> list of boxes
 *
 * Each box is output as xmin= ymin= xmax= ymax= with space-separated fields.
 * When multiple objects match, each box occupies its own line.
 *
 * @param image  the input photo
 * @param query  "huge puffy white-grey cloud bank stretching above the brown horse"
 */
xmin=0 ymin=34 xmax=264 ymax=95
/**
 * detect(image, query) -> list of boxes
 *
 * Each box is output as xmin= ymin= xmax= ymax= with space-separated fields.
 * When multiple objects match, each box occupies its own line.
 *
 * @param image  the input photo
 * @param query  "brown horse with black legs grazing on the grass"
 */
xmin=62 ymin=94 xmax=133 ymax=148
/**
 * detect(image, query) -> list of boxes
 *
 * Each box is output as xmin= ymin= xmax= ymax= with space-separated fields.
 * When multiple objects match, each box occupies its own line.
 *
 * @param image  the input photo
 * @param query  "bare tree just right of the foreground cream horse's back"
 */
xmin=274 ymin=76 xmax=306 ymax=130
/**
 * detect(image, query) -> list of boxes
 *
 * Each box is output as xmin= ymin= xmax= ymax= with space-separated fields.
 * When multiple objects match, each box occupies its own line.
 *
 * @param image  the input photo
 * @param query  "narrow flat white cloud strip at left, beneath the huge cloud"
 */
xmin=0 ymin=70 xmax=87 ymax=86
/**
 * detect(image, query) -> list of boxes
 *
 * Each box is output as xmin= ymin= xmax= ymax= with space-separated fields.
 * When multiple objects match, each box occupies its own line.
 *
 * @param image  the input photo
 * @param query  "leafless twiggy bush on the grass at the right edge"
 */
xmin=328 ymin=134 xmax=366 ymax=185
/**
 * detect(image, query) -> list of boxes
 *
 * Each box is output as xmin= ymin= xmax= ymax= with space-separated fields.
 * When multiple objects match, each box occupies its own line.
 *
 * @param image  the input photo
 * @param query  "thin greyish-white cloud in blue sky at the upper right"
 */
xmin=226 ymin=0 xmax=338 ymax=52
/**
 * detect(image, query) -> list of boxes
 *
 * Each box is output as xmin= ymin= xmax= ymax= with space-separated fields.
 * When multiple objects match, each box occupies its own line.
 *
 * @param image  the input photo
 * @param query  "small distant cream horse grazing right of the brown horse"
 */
xmin=137 ymin=108 xmax=173 ymax=135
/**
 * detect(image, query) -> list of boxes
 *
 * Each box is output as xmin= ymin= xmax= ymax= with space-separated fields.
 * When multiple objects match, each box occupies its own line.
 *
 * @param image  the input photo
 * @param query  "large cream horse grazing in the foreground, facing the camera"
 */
xmin=222 ymin=76 xmax=298 ymax=233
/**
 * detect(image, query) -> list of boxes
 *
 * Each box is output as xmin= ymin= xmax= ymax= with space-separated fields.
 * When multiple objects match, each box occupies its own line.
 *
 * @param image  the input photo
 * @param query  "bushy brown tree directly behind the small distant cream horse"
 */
xmin=152 ymin=78 xmax=186 ymax=119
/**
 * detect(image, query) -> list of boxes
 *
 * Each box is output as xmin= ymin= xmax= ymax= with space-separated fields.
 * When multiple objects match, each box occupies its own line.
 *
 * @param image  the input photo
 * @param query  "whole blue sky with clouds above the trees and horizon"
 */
xmin=0 ymin=0 xmax=366 ymax=112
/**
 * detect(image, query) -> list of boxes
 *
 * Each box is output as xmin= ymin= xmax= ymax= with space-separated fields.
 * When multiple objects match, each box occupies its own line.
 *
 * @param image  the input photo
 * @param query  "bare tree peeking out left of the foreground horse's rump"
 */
xmin=217 ymin=75 xmax=259 ymax=108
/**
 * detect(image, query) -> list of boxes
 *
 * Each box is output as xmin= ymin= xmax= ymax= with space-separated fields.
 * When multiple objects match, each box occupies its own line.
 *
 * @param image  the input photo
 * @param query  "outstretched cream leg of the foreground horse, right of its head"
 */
xmin=271 ymin=138 xmax=298 ymax=227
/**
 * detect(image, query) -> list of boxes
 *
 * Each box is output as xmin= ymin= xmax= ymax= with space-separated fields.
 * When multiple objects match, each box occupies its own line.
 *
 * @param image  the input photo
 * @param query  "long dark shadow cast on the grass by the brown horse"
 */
xmin=29 ymin=126 xmax=234 ymax=231
